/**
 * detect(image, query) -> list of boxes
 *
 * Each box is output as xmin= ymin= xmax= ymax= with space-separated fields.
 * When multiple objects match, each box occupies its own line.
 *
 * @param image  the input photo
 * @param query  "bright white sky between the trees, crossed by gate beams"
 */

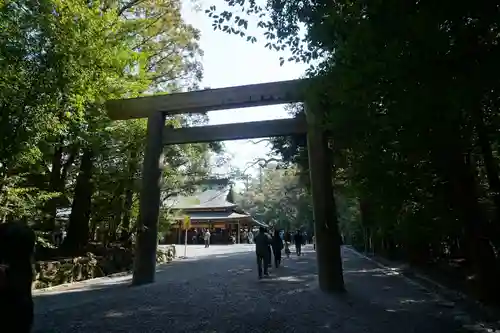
xmin=182 ymin=0 xmax=306 ymax=176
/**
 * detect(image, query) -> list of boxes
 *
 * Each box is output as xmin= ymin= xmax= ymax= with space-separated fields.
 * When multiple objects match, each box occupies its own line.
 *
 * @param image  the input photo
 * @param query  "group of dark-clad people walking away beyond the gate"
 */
xmin=254 ymin=227 xmax=312 ymax=279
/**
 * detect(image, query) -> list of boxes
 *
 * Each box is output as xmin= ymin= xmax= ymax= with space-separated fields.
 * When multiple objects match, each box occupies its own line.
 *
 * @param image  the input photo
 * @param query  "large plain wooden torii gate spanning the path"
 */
xmin=106 ymin=80 xmax=344 ymax=292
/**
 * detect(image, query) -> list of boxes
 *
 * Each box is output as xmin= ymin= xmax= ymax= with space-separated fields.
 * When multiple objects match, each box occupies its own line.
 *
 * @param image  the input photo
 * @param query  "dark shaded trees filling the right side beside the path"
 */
xmin=207 ymin=0 xmax=500 ymax=299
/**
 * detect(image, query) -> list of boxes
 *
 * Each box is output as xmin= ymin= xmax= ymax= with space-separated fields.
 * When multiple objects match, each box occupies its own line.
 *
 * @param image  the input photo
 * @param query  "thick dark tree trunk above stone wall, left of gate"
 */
xmin=63 ymin=149 xmax=94 ymax=254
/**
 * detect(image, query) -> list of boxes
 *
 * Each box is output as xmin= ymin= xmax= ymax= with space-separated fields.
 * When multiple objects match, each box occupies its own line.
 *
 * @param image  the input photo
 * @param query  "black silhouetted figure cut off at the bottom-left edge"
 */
xmin=0 ymin=222 xmax=36 ymax=333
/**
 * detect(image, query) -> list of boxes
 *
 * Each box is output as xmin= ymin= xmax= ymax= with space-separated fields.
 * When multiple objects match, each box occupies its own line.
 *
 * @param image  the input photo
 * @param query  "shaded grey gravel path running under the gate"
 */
xmin=34 ymin=245 xmax=482 ymax=333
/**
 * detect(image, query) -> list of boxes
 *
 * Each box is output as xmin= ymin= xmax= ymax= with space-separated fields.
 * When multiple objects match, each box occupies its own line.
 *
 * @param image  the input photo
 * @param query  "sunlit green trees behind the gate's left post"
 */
xmin=0 ymin=0 xmax=223 ymax=253
